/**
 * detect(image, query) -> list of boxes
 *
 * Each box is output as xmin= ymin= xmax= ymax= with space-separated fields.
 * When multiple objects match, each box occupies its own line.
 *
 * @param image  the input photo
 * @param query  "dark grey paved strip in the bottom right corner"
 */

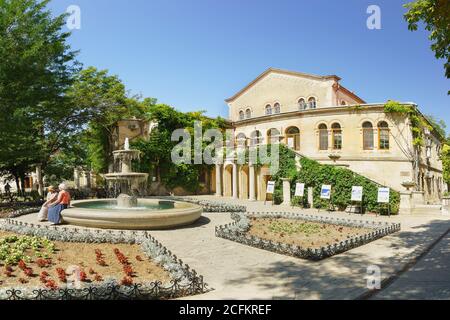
xmin=372 ymin=233 xmax=450 ymax=300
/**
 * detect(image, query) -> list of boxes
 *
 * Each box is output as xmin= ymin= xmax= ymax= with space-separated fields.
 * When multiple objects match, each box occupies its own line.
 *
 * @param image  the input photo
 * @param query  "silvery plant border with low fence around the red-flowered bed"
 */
xmin=0 ymin=218 xmax=211 ymax=300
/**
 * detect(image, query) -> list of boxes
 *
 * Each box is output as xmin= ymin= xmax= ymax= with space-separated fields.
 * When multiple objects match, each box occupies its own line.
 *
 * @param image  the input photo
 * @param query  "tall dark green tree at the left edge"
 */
xmin=0 ymin=0 xmax=80 ymax=192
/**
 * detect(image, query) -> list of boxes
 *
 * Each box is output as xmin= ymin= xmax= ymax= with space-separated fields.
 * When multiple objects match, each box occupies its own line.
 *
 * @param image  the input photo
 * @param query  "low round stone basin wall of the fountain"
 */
xmin=62 ymin=199 xmax=203 ymax=230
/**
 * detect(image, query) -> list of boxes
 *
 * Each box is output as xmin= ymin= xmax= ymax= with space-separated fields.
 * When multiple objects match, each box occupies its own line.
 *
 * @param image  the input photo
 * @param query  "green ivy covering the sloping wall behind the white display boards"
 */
xmin=269 ymin=144 xmax=400 ymax=213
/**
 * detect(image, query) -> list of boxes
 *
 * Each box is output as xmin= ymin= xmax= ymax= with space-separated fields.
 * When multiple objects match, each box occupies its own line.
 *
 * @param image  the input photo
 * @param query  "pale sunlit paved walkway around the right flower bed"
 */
xmin=6 ymin=197 xmax=450 ymax=299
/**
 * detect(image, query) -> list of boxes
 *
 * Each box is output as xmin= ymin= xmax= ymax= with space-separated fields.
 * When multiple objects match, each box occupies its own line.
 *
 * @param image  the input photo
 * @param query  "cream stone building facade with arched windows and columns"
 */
xmin=211 ymin=69 xmax=446 ymax=204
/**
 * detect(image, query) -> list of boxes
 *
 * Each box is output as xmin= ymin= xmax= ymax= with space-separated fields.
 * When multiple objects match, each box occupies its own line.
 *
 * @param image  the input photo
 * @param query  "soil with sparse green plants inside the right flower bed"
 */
xmin=247 ymin=218 xmax=373 ymax=248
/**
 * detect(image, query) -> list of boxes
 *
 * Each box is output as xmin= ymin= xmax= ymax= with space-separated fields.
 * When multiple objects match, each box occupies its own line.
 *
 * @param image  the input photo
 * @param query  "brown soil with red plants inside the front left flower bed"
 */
xmin=0 ymin=231 xmax=170 ymax=288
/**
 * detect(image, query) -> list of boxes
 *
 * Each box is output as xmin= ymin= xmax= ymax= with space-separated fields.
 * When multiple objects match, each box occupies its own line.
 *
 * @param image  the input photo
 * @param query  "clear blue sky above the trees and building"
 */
xmin=50 ymin=0 xmax=450 ymax=131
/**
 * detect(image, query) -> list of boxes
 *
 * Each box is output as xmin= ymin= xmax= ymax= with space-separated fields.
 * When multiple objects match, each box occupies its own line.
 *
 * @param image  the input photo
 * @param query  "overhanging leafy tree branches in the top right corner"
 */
xmin=404 ymin=0 xmax=450 ymax=94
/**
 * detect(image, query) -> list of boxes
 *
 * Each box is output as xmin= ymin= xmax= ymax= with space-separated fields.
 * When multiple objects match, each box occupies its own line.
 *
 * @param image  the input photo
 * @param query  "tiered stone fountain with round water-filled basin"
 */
xmin=62 ymin=138 xmax=203 ymax=230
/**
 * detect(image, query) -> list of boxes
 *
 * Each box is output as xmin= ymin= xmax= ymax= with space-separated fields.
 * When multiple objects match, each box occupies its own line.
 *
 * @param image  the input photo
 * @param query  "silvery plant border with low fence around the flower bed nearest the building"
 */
xmin=216 ymin=212 xmax=401 ymax=261
